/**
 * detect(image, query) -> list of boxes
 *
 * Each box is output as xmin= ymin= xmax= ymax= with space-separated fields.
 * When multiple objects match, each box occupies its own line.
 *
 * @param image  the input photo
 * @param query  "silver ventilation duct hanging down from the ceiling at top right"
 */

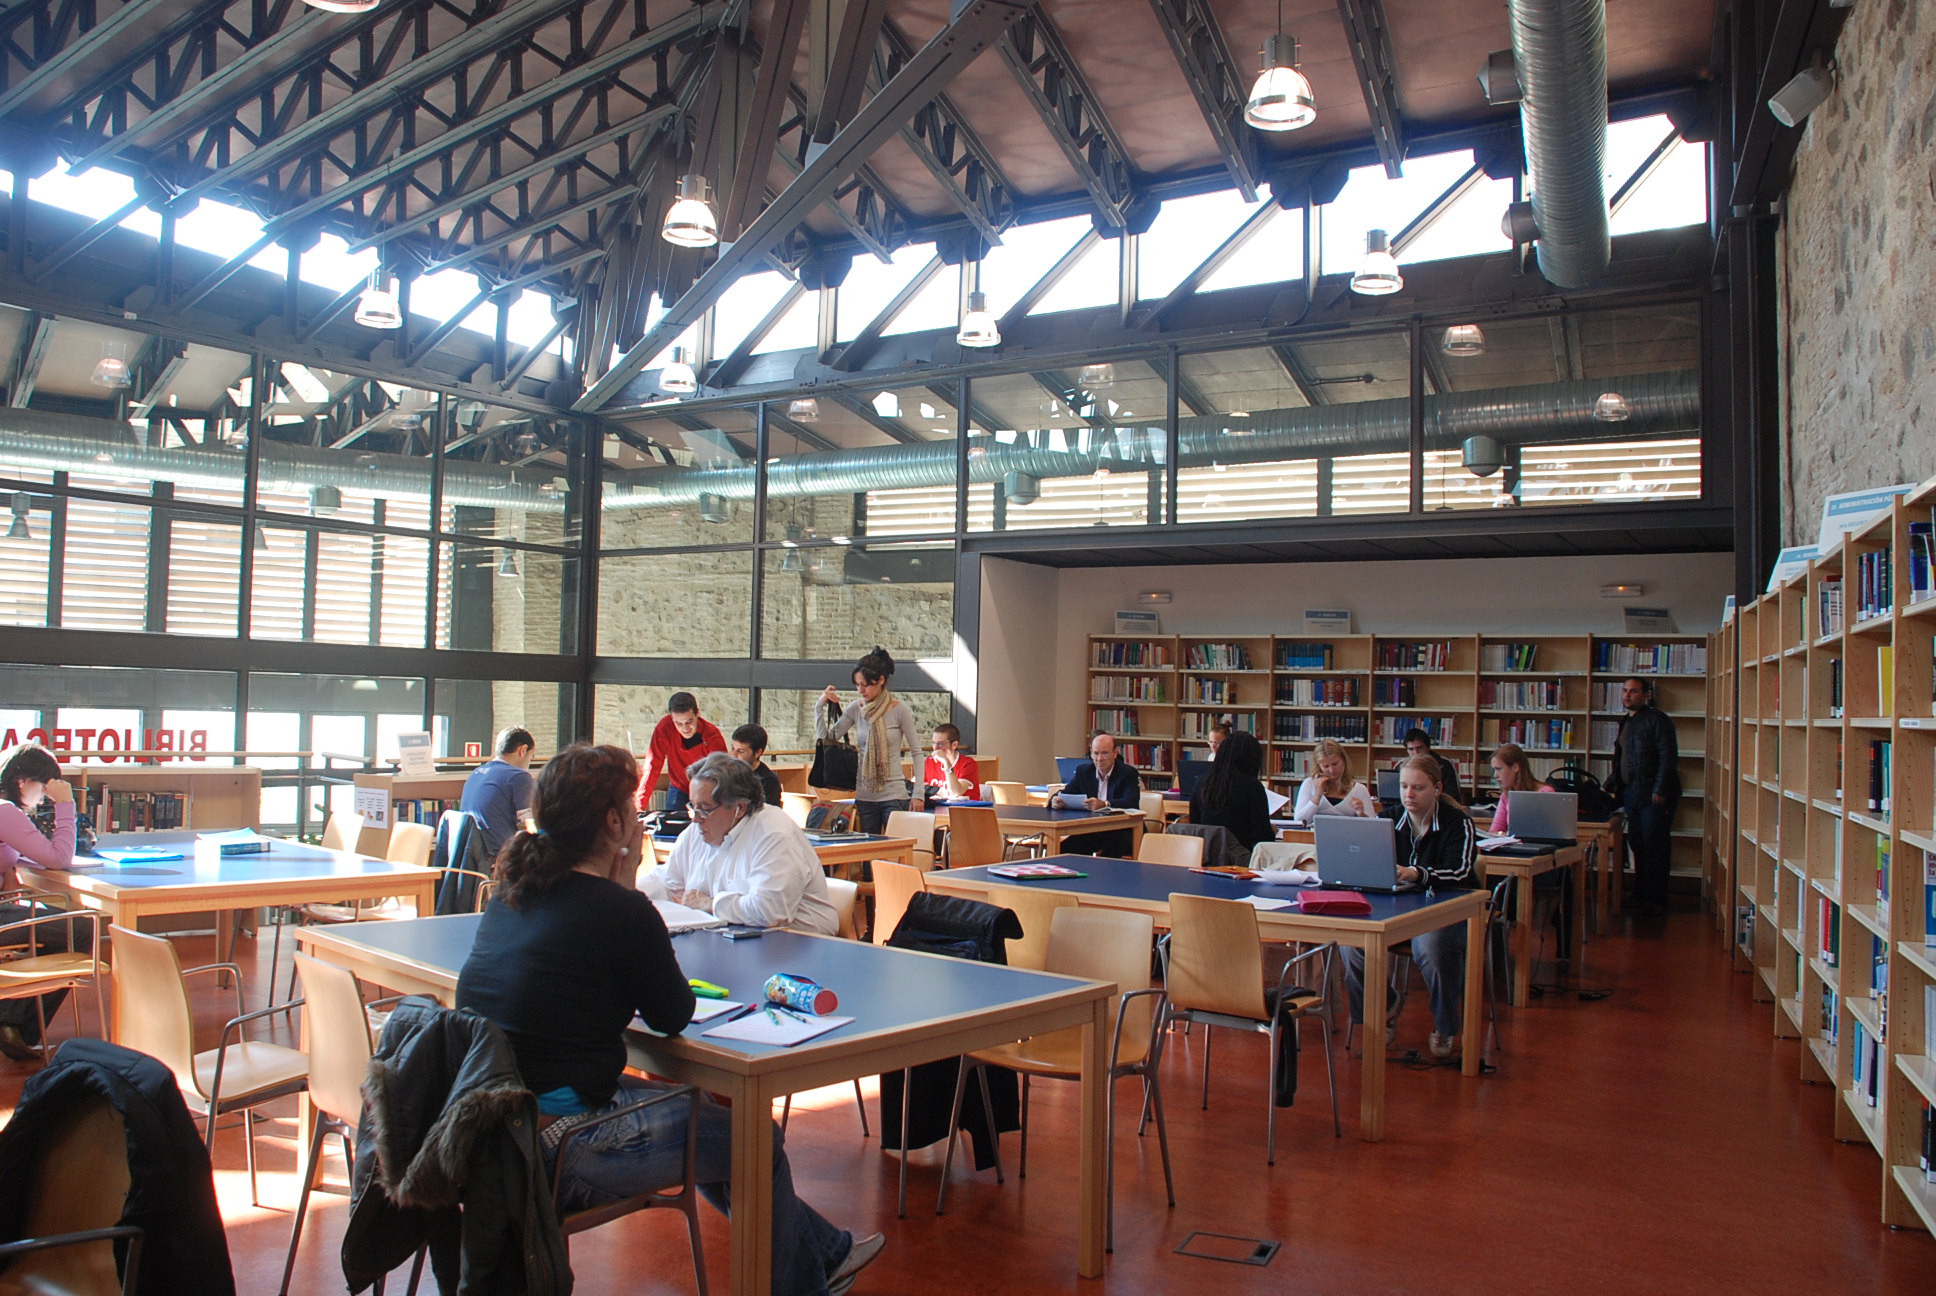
xmin=1506 ymin=0 xmax=1613 ymax=289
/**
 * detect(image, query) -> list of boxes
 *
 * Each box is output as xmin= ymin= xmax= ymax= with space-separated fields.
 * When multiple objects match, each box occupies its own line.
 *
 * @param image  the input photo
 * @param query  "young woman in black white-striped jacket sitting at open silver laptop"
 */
xmin=1344 ymin=754 xmax=1479 ymax=1058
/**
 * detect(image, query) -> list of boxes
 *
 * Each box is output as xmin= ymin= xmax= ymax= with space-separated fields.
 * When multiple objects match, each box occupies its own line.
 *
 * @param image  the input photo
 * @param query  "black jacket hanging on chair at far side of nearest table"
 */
xmin=881 ymin=891 xmax=1022 ymax=1170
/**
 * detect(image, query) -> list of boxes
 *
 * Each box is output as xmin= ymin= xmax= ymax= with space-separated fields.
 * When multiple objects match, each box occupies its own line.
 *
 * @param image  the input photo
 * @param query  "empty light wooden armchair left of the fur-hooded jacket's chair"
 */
xmin=108 ymin=926 xmax=310 ymax=1205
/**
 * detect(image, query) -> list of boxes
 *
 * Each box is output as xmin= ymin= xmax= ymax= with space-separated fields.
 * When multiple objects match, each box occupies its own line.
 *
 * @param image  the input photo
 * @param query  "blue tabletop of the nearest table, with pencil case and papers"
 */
xmin=323 ymin=914 xmax=1084 ymax=1056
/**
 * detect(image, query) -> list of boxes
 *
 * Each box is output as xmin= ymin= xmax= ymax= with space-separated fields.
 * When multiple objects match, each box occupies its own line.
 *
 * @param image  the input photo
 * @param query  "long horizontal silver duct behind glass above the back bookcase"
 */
xmin=602 ymin=370 xmax=1700 ymax=509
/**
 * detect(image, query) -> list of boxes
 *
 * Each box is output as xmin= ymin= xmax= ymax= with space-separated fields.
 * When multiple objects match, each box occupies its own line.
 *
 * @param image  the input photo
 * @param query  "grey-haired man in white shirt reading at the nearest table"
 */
xmin=639 ymin=754 xmax=840 ymax=936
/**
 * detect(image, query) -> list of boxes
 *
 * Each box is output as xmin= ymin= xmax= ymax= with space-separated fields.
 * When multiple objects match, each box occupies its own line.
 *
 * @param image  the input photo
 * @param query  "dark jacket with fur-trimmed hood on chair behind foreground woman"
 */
xmin=343 ymin=1000 xmax=571 ymax=1296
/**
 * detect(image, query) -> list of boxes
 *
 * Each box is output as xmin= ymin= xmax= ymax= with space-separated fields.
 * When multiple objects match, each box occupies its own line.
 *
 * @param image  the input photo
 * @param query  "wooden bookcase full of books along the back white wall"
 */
xmin=1084 ymin=633 xmax=1731 ymax=879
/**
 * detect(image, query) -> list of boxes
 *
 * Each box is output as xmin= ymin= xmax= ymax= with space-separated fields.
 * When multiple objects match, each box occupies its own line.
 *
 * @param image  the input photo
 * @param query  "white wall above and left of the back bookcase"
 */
xmin=980 ymin=554 xmax=1735 ymax=781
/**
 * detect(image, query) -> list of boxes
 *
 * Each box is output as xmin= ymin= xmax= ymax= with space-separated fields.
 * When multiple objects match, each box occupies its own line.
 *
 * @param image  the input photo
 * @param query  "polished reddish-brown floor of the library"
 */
xmin=0 ymin=898 xmax=1936 ymax=1296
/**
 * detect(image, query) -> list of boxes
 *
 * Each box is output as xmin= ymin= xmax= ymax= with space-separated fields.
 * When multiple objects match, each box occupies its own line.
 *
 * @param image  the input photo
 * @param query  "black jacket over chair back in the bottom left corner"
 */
xmin=0 ymin=1038 xmax=236 ymax=1296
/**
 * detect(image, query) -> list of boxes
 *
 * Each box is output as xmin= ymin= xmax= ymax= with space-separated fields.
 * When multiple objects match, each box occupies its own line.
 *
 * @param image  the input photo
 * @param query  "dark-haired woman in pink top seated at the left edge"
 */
xmin=0 ymin=742 xmax=89 ymax=1062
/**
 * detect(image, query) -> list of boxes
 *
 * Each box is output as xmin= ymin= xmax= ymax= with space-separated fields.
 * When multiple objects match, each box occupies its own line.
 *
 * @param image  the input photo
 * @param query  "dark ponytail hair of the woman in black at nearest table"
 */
xmin=492 ymin=742 xmax=639 ymax=909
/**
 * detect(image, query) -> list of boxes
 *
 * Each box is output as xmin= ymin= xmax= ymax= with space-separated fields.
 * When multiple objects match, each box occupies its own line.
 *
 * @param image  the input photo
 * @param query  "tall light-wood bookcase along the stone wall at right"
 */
xmin=1706 ymin=472 xmax=1936 ymax=1230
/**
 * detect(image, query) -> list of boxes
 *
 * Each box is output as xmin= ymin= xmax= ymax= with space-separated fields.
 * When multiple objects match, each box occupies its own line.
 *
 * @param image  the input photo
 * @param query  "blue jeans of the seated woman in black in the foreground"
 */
xmin=548 ymin=1075 xmax=854 ymax=1296
